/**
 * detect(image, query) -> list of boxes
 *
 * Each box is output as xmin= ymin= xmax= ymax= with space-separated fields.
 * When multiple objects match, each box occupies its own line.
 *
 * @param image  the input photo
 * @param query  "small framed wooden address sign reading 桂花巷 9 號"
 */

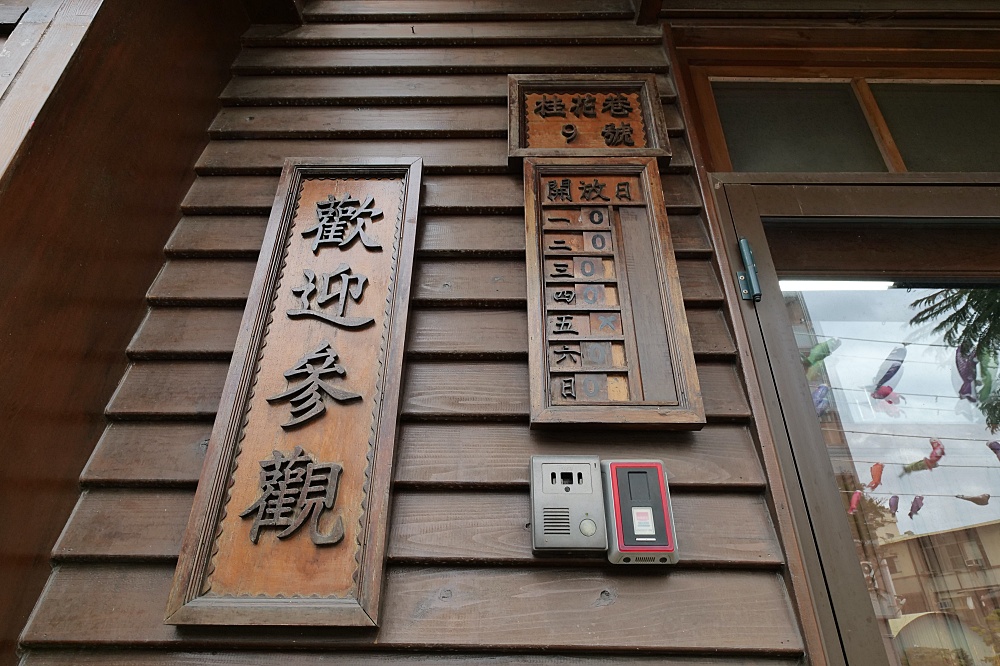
xmin=508 ymin=74 xmax=670 ymax=158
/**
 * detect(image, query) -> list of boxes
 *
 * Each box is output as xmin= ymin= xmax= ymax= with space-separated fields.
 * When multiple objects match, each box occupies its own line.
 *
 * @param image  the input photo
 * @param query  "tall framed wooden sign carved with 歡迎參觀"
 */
xmin=166 ymin=158 xmax=421 ymax=626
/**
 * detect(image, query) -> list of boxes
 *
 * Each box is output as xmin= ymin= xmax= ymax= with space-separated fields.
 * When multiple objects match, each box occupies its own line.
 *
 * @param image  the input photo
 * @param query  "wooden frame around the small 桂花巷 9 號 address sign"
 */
xmin=507 ymin=74 xmax=671 ymax=163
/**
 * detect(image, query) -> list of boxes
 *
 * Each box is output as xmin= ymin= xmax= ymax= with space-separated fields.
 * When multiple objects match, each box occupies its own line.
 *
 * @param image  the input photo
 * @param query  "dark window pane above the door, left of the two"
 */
xmin=712 ymin=81 xmax=886 ymax=171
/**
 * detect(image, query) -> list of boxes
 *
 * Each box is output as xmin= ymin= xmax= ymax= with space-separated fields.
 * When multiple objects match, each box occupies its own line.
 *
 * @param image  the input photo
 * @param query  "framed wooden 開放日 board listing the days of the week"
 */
xmin=524 ymin=158 xmax=705 ymax=429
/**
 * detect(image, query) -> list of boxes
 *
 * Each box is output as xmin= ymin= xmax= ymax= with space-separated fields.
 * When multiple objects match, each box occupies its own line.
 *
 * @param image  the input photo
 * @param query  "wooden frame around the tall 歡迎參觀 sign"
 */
xmin=165 ymin=158 xmax=422 ymax=627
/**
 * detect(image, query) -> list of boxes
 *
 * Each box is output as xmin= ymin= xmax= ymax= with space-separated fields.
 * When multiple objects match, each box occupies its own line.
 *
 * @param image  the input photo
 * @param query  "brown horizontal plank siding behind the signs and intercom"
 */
xmin=17 ymin=0 xmax=803 ymax=666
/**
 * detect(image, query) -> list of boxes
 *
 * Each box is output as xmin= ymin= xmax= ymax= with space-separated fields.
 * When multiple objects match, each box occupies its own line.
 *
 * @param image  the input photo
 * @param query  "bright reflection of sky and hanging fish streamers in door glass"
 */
xmin=783 ymin=283 xmax=1000 ymax=666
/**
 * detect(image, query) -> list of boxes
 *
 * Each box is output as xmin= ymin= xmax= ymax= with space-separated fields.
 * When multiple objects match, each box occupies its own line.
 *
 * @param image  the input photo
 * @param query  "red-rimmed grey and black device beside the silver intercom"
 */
xmin=601 ymin=460 xmax=677 ymax=564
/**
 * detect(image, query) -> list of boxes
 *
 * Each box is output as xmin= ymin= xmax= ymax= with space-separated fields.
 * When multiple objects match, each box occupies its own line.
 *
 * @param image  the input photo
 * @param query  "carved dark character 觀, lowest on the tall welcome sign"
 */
xmin=240 ymin=446 xmax=344 ymax=546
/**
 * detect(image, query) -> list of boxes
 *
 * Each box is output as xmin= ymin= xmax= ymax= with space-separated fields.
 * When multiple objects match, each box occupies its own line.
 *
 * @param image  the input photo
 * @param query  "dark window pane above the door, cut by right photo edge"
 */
xmin=871 ymin=83 xmax=1000 ymax=171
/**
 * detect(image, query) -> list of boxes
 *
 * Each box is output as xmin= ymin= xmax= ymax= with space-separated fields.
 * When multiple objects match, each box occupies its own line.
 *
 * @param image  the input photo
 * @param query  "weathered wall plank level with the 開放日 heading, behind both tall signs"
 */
xmin=182 ymin=174 xmax=701 ymax=215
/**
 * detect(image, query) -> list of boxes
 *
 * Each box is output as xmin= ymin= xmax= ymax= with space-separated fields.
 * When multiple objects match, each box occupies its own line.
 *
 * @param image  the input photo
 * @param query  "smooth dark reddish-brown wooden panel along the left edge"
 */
xmin=0 ymin=0 xmax=245 ymax=663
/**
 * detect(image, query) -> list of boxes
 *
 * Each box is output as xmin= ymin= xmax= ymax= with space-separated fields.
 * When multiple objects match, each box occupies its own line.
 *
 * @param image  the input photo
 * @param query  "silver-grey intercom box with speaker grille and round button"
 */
xmin=531 ymin=456 xmax=608 ymax=551
